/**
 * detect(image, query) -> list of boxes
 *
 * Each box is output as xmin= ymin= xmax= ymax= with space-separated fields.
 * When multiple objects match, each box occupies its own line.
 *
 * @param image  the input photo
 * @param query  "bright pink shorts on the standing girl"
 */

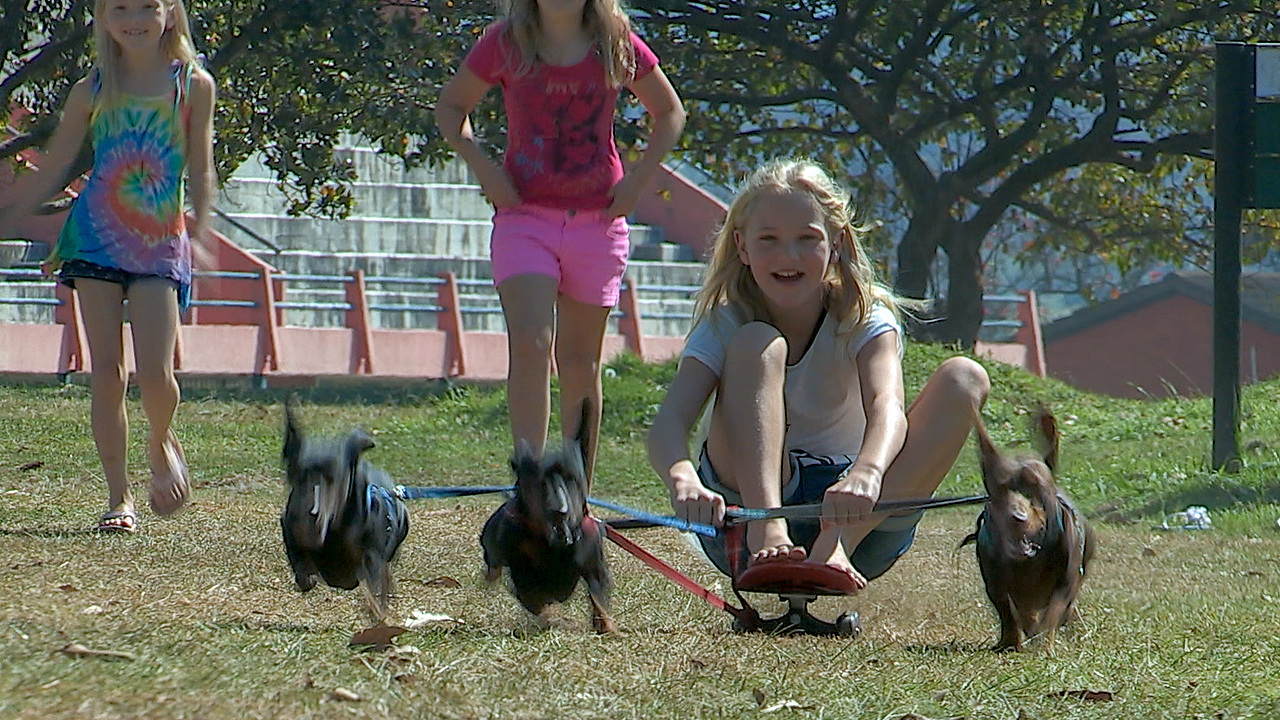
xmin=489 ymin=204 xmax=631 ymax=307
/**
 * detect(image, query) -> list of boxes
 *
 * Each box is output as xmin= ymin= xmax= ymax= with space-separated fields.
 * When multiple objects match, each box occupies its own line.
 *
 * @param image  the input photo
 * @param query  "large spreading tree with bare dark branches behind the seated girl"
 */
xmin=631 ymin=0 xmax=1276 ymax=345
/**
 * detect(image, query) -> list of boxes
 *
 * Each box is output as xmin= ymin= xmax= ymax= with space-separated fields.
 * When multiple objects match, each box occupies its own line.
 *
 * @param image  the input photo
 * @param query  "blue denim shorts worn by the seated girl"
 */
xmin=698 ymin=445 xmax=924 ymax=580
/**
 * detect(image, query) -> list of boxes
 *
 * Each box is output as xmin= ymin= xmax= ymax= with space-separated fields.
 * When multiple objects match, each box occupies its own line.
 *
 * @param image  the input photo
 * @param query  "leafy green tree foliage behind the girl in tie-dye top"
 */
xmin=0 ymin=0 xmax=484 ymax=217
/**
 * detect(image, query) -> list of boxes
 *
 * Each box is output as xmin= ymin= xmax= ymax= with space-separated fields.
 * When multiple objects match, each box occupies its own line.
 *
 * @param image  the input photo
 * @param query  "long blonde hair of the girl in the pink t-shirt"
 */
xmin=499 ymin=0 xmax=636 ymax=87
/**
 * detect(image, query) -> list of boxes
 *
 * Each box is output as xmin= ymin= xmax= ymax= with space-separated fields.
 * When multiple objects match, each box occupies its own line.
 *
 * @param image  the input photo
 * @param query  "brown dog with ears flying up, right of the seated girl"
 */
xmin=960 ymin=409 xmax=1097 ymax=653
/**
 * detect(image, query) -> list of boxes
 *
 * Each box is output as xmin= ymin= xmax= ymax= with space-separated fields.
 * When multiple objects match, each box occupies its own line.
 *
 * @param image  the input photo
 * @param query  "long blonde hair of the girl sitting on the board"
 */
xmin=694 ymin=159 xmax=916 ymax=332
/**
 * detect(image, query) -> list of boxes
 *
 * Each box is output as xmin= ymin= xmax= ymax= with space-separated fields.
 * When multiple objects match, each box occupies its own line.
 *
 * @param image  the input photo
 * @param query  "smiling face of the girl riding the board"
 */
xmin=733 ymin=191 xmax=832 ymax=315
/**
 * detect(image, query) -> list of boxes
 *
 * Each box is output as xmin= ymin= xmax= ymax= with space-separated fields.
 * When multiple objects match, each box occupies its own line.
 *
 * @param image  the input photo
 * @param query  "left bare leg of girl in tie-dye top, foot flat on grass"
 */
xmin=76 ymin=278 xmax=133 ymax=511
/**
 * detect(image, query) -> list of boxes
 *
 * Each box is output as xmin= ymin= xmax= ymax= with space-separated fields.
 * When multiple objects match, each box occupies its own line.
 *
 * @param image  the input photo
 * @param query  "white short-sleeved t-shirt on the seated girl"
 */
xmin=681 ymin=305 xmax=902 ymax=456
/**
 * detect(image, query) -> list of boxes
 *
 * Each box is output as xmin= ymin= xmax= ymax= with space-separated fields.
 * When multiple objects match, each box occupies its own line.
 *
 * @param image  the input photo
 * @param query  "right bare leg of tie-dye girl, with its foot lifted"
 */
xmin=129 ymin=278 xmax=191 ymax=515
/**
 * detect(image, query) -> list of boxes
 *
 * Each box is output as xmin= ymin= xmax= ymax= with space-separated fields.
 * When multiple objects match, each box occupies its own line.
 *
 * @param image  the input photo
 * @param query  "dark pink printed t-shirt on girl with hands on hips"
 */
xmin=466 ymin=22 xmax=658 ymax=210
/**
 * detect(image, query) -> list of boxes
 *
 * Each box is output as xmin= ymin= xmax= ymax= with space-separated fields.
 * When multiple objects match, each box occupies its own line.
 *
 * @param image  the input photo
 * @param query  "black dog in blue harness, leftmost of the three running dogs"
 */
xmin=280 ymin=404 xmax=408 ymax=620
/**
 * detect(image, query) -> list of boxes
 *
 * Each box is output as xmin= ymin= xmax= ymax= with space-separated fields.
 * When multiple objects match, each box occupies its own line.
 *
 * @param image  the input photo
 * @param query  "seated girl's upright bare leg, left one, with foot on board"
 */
xmin=707 ymin=323 xmax=806 ymax=562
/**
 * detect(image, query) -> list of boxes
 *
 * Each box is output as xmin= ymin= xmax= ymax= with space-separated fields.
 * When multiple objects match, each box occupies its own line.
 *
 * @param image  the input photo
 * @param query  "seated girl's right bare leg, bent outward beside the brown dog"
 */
xmin=812 ymin=357 xmax=991 ymax=573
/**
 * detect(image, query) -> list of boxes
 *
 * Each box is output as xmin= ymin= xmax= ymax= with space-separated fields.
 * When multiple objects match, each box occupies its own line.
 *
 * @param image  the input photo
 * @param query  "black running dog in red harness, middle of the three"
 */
xmin=480 ymin=402 xmax=614 ymax=633
